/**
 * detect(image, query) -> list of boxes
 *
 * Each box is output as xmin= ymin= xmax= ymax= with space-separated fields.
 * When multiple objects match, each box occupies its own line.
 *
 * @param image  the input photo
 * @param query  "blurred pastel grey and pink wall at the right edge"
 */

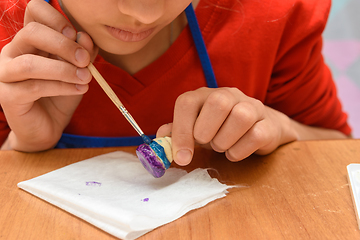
xmin=323 ymin=0 xmax=360 ymax=138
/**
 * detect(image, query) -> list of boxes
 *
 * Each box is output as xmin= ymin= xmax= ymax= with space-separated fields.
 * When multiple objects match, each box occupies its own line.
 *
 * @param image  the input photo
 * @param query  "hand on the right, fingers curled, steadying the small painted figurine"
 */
xmin=157 ymin=88 xmax=297 ymax=165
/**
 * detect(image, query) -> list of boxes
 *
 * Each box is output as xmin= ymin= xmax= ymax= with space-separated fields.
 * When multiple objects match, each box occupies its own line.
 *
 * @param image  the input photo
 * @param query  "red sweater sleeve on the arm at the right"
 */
xmin=265 ymin=1 xmax=351 ymax=135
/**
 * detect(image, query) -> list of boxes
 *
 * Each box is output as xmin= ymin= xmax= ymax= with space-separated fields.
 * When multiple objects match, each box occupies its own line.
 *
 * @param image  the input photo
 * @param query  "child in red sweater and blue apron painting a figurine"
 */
xmin=0 ymin=0 xmax=351 ymax=165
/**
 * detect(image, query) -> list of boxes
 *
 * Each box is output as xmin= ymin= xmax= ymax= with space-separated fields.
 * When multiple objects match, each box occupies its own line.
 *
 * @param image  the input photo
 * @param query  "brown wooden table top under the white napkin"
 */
xmin=0 ymin=140 xmax=360 ymax=240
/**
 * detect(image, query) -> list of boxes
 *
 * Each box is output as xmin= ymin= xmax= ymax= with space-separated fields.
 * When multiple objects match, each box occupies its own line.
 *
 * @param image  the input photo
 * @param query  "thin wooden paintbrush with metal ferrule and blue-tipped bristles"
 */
xmin=88 ymin=62 xmax=151 ymax=144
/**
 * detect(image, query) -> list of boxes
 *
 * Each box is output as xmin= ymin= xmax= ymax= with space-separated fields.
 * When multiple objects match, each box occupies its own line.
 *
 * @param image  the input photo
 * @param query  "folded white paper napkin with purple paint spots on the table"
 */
xmin=18 ymin=151 xmax=231 ymax=239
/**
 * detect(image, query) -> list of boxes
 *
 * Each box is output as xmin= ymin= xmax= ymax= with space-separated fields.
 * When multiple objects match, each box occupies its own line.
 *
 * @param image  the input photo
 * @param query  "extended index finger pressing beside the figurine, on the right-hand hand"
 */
xmin=172 ymin=90 xmax=208 ymax=166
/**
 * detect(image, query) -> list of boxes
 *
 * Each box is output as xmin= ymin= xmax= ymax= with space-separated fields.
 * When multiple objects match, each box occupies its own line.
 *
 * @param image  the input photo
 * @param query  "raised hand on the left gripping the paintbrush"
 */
xmin=0 ymin=0 xmax=96 ymax=151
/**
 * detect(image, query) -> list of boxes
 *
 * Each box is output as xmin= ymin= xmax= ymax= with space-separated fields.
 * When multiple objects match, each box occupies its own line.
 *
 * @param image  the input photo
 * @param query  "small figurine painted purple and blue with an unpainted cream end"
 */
xmin=136 ymin=137 xmax=173 ymax=178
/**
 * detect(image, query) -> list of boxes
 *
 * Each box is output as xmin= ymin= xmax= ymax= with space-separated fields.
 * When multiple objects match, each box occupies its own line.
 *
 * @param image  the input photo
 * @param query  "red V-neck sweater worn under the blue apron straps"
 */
xmin=0 ymin=0 xmax=351 ymax=144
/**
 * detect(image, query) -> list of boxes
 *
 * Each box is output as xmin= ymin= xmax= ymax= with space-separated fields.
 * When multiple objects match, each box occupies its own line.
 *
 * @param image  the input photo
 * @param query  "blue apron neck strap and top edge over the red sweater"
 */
xmin=45 ymin=0 xmax=217 ymax=148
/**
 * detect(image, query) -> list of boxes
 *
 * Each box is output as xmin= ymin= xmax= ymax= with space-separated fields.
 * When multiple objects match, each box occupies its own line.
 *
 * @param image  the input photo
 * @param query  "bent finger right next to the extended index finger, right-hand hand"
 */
xmin=194 ymin=88 xmax=238 ymax=144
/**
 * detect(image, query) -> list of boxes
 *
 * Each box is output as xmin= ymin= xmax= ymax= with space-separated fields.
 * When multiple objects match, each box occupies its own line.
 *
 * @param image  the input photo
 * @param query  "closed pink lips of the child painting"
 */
xmin=107 ymin=26 xmax=154 ymax=42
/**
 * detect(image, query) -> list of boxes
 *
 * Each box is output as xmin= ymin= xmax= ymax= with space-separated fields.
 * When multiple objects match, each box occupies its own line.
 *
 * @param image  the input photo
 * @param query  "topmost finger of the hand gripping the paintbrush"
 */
xmin=24 ymin=0 xmax=76 ymax=41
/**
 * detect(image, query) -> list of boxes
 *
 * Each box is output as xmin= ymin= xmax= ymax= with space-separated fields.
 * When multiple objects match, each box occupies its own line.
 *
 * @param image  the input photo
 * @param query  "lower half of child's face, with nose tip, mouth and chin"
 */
xmin=59 ymin=0 xmax=191 ymax=54
